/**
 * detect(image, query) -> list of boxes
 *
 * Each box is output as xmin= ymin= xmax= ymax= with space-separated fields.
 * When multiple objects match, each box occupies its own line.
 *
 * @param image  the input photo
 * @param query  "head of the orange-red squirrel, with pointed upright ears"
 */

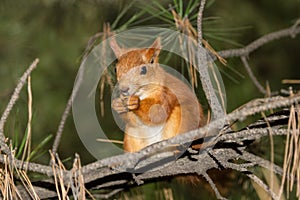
xmin=110 ymin=37 xmax=162 ymax=98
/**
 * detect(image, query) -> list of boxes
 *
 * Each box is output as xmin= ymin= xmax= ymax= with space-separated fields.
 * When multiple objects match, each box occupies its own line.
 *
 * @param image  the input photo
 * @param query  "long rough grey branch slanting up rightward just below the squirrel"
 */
xmin=82 ymin=94 xmax=300 ymax=179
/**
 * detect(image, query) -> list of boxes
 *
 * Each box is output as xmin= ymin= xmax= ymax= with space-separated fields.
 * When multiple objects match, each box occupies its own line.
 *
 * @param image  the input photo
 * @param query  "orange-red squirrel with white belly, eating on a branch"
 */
xmin=110 ymin=37 xmax=204 ymax=152
